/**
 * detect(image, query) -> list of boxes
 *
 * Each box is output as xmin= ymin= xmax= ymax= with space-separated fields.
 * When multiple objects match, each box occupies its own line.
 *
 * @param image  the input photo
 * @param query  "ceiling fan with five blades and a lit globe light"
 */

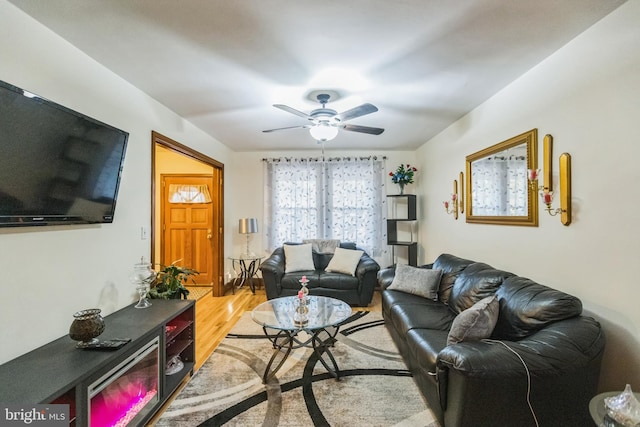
xmin=263 ymin=93 xmax=384 ymax=142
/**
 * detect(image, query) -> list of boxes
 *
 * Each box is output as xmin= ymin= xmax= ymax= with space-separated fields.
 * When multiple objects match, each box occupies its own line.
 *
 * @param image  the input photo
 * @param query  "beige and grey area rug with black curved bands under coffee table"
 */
xmin=156 ymin=312 xmax=438 ymax=427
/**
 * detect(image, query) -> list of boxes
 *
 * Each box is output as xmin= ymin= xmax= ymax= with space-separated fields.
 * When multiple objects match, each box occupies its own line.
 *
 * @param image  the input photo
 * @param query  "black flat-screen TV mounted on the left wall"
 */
xmin=0 ymin=81 xmax=129 ymax=227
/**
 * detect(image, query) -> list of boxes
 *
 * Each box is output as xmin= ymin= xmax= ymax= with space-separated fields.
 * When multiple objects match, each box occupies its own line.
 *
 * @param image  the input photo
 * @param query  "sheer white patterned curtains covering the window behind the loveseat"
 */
xmin=264 ymin=157 xmax=386 ymax=256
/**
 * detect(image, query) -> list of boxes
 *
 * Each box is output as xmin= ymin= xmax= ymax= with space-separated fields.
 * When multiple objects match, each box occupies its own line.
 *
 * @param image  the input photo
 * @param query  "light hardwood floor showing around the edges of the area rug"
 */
xmin=147 ymin=287 xmax=382 ymax=426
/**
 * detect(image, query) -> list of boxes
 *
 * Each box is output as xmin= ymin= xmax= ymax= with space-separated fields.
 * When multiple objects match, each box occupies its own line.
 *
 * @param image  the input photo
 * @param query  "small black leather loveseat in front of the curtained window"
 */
xmin=260 ymin=242 xmax=380 ymax=306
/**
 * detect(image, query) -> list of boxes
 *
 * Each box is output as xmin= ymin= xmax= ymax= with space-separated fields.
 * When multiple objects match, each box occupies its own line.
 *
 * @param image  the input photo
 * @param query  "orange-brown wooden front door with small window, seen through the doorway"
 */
xmin=161 ymin=175 xmax=217 ymax=285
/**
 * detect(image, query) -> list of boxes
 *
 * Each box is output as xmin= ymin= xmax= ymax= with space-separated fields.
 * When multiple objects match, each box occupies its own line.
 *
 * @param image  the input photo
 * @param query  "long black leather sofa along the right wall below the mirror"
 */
xmin=379 ymin=254 xmax=605 ymax=427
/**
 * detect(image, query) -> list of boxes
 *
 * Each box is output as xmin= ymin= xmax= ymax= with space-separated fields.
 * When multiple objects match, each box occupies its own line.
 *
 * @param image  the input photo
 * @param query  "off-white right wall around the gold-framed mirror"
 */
xmin=418 ymin=1 xmax=640 ymax=390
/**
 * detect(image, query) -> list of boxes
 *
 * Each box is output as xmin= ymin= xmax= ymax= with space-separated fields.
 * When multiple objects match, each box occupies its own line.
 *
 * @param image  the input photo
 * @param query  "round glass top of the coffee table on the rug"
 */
xmin=251 ymin=295 xmax=351 ymax=331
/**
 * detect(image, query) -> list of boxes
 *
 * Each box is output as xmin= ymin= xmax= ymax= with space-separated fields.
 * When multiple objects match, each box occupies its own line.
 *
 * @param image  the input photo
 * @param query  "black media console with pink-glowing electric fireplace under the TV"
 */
xmin=0 ymin=300 xmax=195 ymax=427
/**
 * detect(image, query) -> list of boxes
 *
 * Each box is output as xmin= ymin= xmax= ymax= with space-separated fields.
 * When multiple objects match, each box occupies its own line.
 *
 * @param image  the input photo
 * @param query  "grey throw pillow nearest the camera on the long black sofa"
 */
xmin=447 ymin=295 xmax=500 ymax=345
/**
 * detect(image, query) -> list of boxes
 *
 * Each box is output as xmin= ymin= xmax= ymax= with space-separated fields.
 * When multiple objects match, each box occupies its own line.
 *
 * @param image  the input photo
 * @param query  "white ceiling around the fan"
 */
xmin=9 ymin=0 xmax=624 ymax=151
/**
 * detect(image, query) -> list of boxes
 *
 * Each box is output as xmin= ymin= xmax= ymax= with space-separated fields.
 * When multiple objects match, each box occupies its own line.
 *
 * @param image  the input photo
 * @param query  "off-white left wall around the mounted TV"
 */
xmin=0 ymin=0 xmax=233 ymax=363
